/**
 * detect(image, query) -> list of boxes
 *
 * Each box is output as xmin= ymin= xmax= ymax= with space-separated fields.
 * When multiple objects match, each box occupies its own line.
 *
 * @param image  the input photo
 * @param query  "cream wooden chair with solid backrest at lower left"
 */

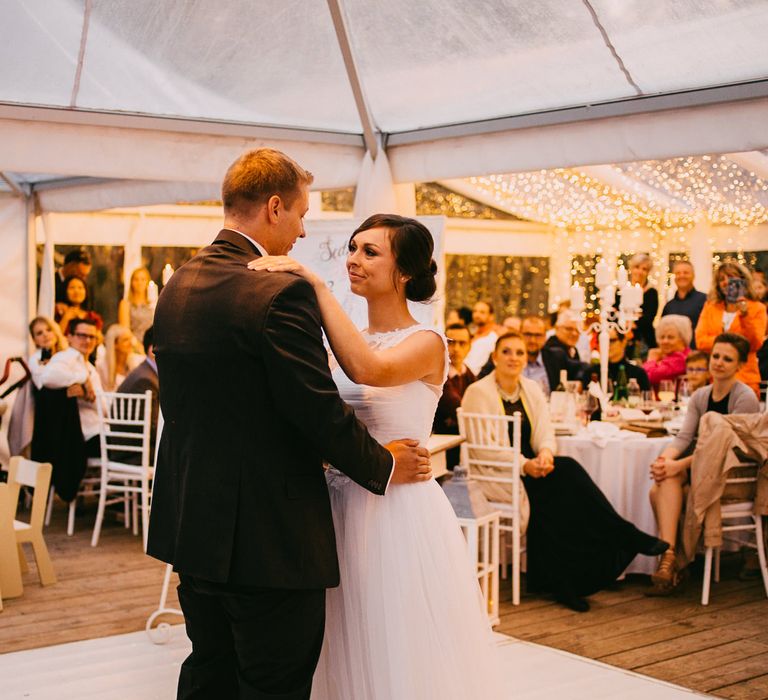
xmin=8 ymin=457 xmax=56 ymax=586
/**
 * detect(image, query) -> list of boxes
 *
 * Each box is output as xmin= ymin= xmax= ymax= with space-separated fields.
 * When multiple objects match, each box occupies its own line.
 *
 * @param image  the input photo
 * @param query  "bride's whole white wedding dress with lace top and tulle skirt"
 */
xmin=312 ymin=325 xmax=501 ymax=700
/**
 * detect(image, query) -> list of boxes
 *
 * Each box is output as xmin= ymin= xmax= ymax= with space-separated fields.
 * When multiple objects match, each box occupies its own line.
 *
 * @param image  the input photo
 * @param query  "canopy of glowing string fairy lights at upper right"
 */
xmin=468 ymin=155 xmax=768 ymax=314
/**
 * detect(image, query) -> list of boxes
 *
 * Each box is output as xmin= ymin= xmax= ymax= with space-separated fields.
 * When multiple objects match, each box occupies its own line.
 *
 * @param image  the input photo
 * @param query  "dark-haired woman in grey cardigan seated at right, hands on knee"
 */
xmin=649 ymin=333 xmax=760 ymax=595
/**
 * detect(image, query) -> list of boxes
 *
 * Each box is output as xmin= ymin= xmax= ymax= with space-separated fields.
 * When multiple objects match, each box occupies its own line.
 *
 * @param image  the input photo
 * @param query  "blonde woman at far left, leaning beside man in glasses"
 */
xmin=8 ymin=316 xmax=67 ymax=457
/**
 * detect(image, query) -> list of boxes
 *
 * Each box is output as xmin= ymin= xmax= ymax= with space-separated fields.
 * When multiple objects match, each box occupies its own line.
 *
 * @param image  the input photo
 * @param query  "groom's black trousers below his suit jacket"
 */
xmin=177 ymin=574 xmax=325 ymax=700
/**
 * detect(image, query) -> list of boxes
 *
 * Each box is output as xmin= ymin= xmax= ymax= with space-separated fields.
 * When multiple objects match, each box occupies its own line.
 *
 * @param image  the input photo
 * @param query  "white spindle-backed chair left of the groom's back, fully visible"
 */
xmin=91 ymin=390 xmax=154 ymax=551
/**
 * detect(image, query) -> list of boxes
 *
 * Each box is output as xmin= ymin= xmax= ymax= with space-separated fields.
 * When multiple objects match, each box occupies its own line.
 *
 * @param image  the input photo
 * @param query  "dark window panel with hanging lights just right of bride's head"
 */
xmin=445 ymin=255 xmax=549 ymax=323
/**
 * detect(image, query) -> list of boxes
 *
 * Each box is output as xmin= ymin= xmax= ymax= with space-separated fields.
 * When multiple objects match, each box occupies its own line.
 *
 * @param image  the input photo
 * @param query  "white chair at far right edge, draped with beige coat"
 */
xmin=701 ymin=463 xmax=768 ymax=605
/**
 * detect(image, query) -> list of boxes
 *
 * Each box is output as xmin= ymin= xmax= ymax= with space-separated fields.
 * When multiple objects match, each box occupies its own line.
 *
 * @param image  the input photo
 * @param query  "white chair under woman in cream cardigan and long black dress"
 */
xmin=456 ymin=409 xmax=522 ymax=605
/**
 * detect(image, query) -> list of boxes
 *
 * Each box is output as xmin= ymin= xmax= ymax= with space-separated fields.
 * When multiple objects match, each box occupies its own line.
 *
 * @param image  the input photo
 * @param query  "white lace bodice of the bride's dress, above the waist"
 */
xmin=332 ymin=324 xmax=448 ymax=484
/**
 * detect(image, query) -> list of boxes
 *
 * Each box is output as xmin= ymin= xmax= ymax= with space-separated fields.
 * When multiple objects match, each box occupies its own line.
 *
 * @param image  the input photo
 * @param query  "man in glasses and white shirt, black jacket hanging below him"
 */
xmin=32 ymin=318 xmax=101 ymax=501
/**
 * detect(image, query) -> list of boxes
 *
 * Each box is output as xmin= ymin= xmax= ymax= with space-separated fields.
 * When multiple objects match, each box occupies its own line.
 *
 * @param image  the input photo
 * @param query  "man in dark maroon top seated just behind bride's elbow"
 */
xmin=432 ymin=323 xmax=475 ymax=471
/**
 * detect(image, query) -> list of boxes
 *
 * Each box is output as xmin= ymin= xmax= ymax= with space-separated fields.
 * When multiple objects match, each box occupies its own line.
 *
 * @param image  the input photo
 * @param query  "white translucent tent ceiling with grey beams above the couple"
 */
xmin=0 ymin=0 xmax=768 ymax=194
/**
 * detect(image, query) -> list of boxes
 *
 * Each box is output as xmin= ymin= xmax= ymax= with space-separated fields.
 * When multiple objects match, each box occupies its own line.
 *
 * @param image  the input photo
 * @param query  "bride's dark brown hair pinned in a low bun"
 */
xmin=349 ymin=214 xmax=437 ymax=301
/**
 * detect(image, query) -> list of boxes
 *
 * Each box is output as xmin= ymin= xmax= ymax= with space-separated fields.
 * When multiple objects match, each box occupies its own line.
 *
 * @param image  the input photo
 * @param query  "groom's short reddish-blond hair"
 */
xmin=221 ymin=148 xmax=315 ymax=213
